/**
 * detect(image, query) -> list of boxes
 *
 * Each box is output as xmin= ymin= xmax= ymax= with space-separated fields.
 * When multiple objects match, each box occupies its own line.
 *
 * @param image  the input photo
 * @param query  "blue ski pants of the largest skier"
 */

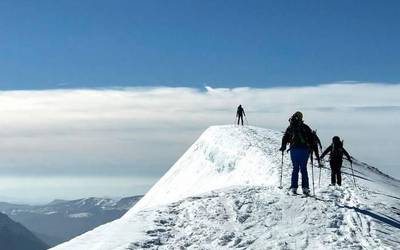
xmin=290 ymin=147 xmax=310 ymax=188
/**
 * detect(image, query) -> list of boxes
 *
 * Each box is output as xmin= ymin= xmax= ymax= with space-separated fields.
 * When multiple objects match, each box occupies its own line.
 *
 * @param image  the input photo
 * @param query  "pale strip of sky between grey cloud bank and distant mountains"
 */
xmin=0 ymin=176 xmax=157 ymax=204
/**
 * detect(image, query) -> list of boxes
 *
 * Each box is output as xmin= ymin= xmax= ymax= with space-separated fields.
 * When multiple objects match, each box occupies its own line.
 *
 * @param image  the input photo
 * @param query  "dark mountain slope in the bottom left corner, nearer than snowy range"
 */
xmin=0 ymin=213 xmax=49 ymax=250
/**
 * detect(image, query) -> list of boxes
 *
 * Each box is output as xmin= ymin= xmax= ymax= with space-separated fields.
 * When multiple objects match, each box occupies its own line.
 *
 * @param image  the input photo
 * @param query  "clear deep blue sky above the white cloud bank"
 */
xmin=0 ymin=0 xmax=400 ymax=90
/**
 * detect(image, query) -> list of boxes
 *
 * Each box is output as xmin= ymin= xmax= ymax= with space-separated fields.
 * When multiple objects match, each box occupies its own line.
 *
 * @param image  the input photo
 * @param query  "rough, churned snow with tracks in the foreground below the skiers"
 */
xmin=127 ymin=187 xmax=400 ymax=250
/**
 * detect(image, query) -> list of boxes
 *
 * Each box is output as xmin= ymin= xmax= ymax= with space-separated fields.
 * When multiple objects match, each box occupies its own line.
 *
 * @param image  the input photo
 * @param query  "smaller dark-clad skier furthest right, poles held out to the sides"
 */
xmin=321 ymin=136 xmax=353 ymax=186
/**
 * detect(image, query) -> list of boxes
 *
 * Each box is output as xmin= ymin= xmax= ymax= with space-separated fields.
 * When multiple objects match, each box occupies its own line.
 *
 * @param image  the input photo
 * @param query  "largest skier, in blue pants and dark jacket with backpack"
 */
xmin=279 ymin=111 xmax=320 ymax=195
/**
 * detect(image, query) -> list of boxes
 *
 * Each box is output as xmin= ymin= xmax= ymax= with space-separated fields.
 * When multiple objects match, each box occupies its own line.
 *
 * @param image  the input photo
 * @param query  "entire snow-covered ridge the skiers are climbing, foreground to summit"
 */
xmin=53 ymin=126 xmax=400 ymax=250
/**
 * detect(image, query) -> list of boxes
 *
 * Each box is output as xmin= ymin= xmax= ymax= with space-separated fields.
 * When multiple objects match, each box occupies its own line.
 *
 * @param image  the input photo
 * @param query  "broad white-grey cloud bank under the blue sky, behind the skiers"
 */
xmin=0 ymin=83 xmax=400 ymax=202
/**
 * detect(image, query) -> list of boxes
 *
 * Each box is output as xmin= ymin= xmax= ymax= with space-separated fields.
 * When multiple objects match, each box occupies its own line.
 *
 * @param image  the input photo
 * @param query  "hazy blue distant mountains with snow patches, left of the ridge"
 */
xmin=0 ymin=196 xmax=142 ymax=246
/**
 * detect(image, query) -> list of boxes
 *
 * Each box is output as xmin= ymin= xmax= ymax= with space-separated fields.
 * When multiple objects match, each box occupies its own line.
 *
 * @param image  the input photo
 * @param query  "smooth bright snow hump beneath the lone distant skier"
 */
xmin=128 ymin=126 xmax=282 ymax=213
